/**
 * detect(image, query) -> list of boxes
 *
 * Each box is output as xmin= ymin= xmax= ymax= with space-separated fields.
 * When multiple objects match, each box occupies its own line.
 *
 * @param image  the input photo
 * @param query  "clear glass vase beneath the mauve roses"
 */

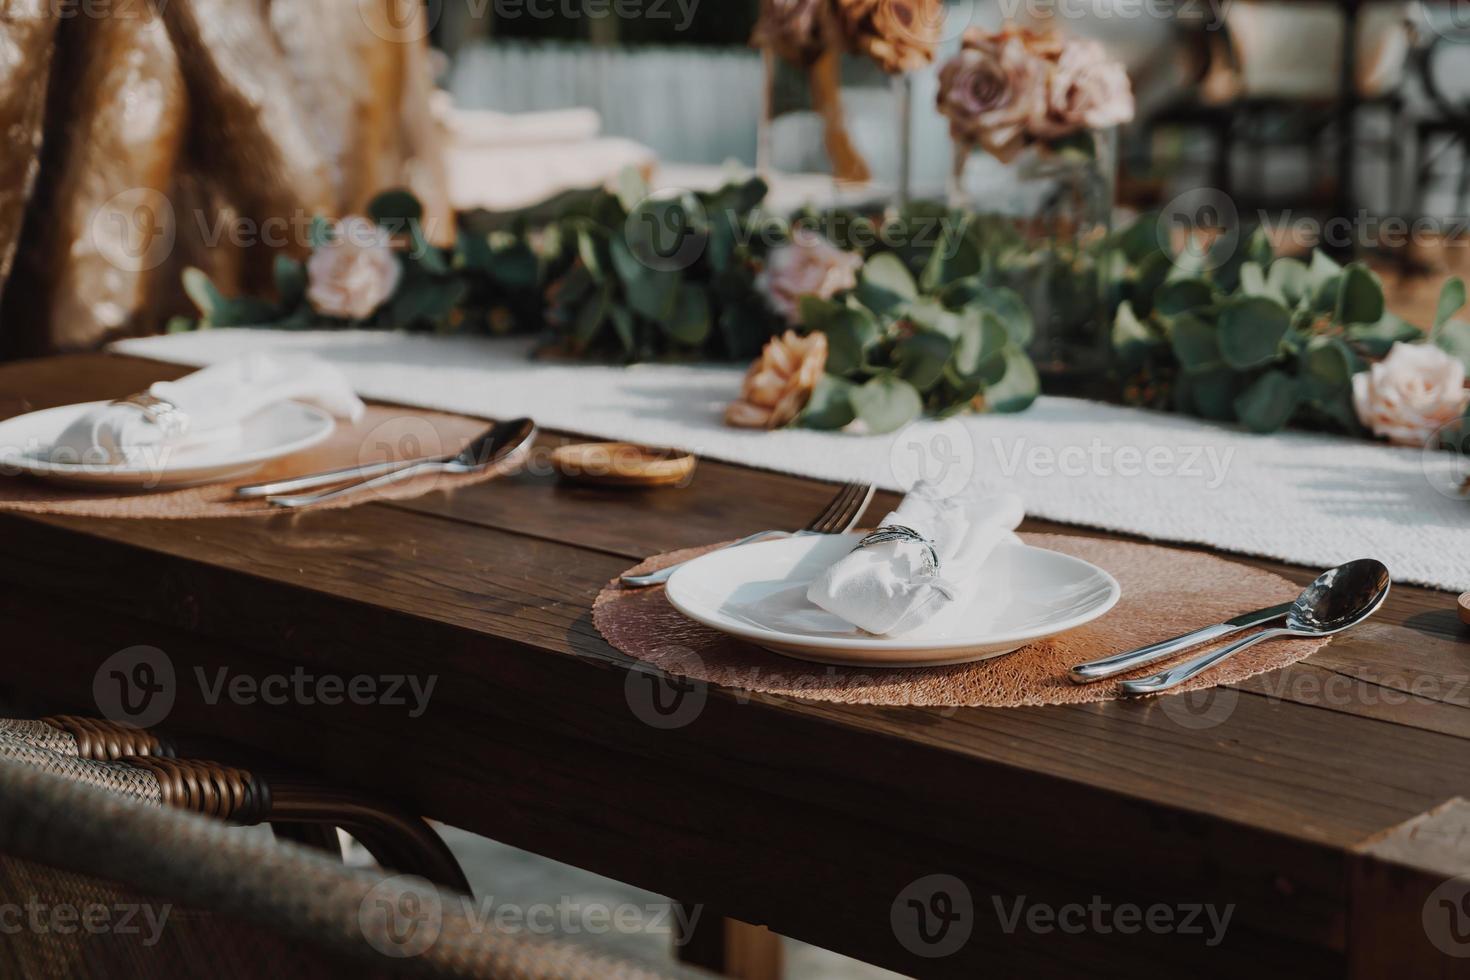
xmin=950 ymin=129 xmax=1117 ymax=379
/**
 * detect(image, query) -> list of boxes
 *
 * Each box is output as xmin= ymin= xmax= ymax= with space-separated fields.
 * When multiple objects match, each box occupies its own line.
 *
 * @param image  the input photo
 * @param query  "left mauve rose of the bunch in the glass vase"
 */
xmin=939 ymin=37 xmax=1047 ymax=160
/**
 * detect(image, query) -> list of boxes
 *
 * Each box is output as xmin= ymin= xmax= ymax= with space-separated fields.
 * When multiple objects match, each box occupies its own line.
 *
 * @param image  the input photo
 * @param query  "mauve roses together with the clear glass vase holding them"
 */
xmin=938 ymin=25 xmax=1133 ymax=375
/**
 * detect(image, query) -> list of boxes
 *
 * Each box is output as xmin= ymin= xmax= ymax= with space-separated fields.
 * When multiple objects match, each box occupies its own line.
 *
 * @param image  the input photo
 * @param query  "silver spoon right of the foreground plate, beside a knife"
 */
xmin=1119 ymin=558 xmax=1391 ymax=693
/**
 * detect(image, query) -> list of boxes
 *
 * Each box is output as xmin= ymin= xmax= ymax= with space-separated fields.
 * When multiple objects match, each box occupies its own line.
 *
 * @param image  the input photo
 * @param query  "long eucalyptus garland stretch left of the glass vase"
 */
xmin=171 ymin=172 xmax=1039 ymax=432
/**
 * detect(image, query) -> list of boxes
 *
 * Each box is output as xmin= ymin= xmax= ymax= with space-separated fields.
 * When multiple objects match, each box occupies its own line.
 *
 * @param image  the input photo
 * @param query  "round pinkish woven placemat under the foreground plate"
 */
xmin=592 ymin=535 xmax=1327 ymax=707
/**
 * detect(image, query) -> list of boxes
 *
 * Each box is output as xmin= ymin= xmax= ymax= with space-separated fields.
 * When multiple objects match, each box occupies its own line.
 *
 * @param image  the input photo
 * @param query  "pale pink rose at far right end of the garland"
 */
xmin=1352 ymin=344 xmax=1470 ymax=447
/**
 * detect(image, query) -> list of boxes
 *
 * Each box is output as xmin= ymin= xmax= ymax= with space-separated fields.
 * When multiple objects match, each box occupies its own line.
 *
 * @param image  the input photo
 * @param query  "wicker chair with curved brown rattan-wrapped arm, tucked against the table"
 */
xmin=0 ymin=716 xmax=470 ymax=893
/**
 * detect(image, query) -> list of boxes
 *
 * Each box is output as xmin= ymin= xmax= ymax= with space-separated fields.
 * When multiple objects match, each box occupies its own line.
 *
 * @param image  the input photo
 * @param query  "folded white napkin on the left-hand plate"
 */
xmin=50 ymin=354 xmax=365 ymax=464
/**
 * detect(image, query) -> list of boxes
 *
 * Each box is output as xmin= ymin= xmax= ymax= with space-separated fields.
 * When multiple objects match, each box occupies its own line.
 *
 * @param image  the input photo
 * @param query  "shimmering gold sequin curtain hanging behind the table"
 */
xmin=0 ymin=0 xmax=453 ymax=357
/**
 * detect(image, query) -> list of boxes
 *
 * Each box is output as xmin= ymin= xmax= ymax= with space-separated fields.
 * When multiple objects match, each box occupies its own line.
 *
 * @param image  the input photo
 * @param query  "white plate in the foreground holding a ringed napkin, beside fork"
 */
xmin=667 ymin=533 xmax=1122 ymax=667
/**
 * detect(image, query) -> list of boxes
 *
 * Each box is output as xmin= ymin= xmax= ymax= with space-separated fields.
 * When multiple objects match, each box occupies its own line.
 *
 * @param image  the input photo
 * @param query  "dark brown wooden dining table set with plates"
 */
xmin=0 ymin=354 xmax=1470 ymax=977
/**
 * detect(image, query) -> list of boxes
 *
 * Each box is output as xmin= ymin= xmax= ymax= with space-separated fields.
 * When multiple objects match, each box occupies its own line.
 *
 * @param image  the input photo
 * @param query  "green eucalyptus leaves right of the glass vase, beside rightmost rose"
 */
xmin=1107 ymin=215 xmax=1470 ymax=435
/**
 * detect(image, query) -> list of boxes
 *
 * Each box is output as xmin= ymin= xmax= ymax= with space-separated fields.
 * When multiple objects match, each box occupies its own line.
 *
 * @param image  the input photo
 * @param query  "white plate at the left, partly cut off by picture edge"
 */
xmin=0 ymin=401 xmax=337 ymax=489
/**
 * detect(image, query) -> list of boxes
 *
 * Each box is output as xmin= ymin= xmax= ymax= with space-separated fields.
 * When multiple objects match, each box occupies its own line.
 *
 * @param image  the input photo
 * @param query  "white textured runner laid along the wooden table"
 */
xmin=115 ymin=329 xmax=1470 ymax=591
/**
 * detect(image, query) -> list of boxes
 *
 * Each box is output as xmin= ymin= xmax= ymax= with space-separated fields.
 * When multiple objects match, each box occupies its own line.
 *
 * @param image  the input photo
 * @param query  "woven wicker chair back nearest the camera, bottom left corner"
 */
xmin=0 ymin=758 xmax=691 ymax=980
